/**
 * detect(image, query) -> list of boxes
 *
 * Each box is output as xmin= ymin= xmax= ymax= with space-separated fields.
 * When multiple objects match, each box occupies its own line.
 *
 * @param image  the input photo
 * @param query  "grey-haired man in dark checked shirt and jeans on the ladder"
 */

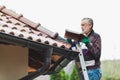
xmin=76 ymin=18 xmax=102 ymax=80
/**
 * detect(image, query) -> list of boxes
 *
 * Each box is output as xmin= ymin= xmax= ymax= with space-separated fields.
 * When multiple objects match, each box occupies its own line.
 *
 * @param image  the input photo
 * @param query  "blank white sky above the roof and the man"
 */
xmin=0 ymin=0 xmax=120 ymax=60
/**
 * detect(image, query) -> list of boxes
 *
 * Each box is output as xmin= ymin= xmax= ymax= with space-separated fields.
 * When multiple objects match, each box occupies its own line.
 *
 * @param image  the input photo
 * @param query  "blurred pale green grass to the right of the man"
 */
xmin=101 ymin=60 xmax=120 ymax=80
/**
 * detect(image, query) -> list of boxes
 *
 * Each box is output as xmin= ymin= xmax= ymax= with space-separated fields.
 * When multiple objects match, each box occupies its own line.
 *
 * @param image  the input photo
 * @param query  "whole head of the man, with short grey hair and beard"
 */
xmin=81 ymin=17 xmax=93 ymax=35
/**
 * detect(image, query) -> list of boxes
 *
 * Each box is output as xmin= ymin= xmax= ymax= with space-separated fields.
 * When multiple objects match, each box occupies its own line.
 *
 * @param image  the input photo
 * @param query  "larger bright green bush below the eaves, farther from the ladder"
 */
xmin=50 ymin=69 xmax=69 ymax=80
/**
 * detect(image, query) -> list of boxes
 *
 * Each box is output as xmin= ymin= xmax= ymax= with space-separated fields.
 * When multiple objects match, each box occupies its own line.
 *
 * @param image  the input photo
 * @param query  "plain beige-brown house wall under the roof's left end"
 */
xmin=0 ymin=44 xmax=28 ymax=80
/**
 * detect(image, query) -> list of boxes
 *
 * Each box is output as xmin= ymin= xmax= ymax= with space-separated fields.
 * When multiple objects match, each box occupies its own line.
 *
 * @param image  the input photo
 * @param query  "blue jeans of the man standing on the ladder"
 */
xmin=79 ymin=68 xmax=102 ymax=80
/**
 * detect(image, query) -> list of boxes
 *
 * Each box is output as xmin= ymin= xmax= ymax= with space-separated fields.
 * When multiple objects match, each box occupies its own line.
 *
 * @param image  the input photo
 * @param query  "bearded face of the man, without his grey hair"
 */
xmin=81 ymin=20 xmax=92 ymax=35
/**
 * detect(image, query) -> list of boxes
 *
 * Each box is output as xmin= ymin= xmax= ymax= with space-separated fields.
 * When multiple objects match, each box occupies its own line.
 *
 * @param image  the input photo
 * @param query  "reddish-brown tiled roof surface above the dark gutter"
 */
xmin=0 ymin=6 xmax=70 ymax=48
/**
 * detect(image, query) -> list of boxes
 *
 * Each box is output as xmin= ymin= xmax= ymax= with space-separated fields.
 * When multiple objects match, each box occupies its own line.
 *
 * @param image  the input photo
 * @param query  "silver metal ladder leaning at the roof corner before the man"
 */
xmin=76 ymin=42 xmax=89 ymax=80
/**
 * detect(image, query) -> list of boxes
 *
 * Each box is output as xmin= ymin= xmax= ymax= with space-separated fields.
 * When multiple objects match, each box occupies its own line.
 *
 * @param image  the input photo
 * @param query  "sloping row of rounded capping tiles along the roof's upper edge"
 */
xmin=0 ymin=6 xmax=58 ymax=39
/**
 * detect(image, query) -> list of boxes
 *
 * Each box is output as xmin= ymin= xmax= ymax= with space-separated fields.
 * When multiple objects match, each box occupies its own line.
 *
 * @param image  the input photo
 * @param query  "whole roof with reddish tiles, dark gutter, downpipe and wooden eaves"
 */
xmin=0 ymin=6 xmax=78 ymax=80
